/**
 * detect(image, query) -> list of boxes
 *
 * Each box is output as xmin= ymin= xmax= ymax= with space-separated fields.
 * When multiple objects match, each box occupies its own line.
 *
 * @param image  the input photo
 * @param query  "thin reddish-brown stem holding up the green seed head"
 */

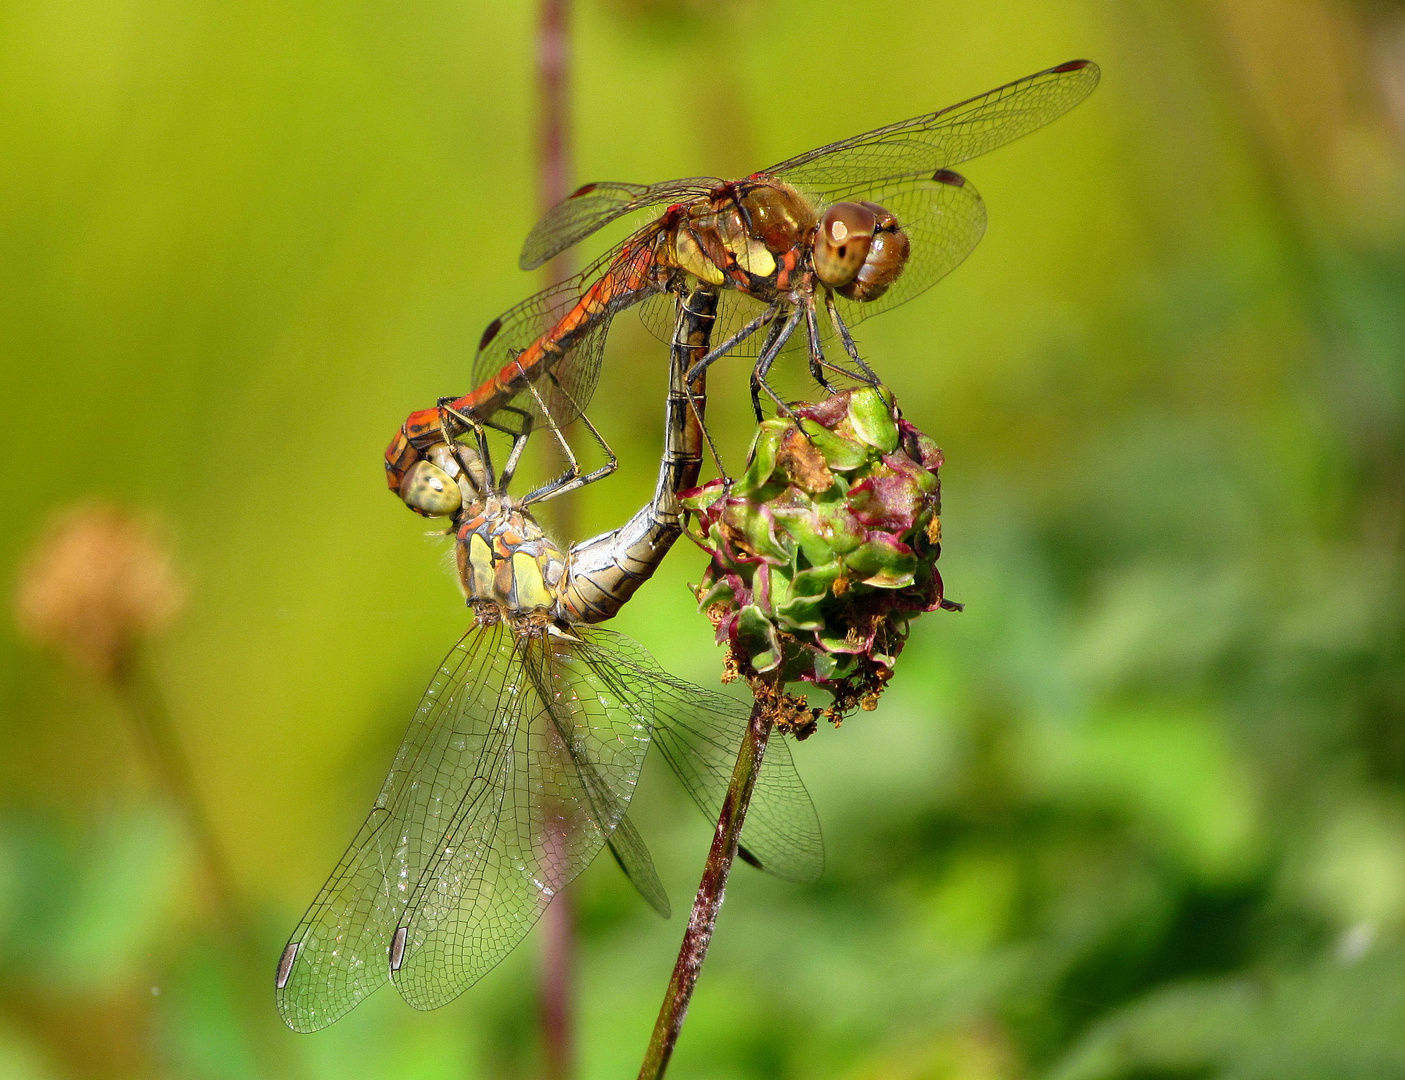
xmin=639 ymin=674 xmax=781 ymax=1080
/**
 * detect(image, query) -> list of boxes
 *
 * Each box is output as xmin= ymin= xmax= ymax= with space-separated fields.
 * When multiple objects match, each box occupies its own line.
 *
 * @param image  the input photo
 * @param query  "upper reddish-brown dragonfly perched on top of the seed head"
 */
xmin=386 ymin=60 xmax=1099 ymax=505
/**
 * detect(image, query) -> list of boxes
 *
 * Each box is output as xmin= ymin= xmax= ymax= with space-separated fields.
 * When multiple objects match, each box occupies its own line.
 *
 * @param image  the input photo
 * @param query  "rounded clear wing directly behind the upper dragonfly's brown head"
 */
xmin=825 ymin=171 xmax=985 ymax=326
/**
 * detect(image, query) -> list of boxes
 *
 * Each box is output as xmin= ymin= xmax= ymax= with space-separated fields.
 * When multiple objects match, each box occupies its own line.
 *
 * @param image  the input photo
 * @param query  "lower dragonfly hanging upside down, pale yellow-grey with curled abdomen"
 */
xmin=275 ymin=291 xmax=823 ymax=1031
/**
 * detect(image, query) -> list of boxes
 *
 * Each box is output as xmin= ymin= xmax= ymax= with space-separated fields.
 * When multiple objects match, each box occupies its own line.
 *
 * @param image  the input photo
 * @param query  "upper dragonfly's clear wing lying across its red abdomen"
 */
xmin=473 ymin=240 xmax=655 ymax=424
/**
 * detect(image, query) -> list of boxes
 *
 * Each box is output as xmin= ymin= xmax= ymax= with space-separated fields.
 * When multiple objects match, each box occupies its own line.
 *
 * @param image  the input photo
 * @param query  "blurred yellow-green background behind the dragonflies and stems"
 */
xmin=0 ymin=0 xmax=1405 ymax=1080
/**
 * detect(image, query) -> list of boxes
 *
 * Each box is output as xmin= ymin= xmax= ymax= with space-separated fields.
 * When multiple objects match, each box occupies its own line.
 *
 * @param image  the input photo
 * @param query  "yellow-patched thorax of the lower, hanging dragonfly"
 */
xmin=454 ymin=496 xmax=566 ymax=618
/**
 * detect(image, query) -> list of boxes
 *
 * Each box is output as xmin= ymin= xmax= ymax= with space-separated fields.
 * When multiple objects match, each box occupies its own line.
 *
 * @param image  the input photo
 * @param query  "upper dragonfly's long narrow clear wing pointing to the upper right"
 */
xmin=763 ymin=60 xmax=1100 ymax=191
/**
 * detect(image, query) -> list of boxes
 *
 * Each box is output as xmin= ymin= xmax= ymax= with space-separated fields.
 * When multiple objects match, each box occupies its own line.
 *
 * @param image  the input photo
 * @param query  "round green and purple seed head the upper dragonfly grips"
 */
xmin=683 ymin=388 xmax=960 ymax=733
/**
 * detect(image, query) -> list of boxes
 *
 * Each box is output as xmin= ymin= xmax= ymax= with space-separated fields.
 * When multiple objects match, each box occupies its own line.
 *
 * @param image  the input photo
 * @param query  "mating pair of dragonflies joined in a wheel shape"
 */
xmin=277 ymin=60 xmax=1099 ymax=1031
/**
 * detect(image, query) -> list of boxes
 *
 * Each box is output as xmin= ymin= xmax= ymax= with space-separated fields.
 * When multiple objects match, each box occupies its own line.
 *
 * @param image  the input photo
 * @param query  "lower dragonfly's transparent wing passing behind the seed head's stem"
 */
xmin=576 ymin=626 xmax=825 ymax=882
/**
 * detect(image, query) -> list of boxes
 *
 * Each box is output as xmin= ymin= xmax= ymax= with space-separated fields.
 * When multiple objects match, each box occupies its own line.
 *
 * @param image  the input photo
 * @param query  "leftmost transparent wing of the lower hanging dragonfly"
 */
xmin=277 ymin=625 xmax=516 ymax=1031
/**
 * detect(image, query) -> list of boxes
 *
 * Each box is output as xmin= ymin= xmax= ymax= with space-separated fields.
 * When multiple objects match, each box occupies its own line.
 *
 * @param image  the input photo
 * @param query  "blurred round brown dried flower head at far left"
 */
xmin=15 ymin=503 xmax=185 ymax=680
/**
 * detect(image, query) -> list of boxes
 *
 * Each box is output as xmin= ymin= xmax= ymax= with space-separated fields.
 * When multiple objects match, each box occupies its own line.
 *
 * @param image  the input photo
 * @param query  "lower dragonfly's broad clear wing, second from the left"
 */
xmin=392 ymin=623 xmax=652 ymax=1008
